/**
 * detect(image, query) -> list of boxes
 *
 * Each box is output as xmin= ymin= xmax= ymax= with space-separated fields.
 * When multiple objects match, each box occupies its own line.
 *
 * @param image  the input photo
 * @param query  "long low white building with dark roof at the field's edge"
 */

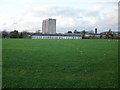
xmin=31 ymin=34 xmax=82 ymax=39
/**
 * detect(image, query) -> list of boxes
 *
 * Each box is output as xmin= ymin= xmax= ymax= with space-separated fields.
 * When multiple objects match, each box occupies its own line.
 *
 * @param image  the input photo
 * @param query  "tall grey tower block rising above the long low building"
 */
xmin=42 ymin=19 xmax=56 ymax=34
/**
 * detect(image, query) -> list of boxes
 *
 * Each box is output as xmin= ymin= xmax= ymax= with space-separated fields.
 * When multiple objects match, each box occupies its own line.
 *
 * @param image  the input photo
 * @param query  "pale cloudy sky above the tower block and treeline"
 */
xmin=0 ymin=0 xmax=119 ymax=33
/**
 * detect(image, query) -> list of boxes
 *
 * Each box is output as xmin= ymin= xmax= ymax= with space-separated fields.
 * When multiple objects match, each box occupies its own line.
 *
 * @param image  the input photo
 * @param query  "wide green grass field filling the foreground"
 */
xmin=2 ymin=39 xmax=118 ymax=88
